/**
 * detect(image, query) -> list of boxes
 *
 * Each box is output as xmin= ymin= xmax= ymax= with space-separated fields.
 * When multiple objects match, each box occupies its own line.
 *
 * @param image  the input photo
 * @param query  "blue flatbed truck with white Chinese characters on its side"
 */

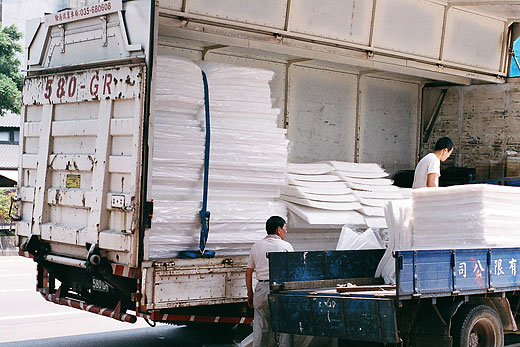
xmin=269 ymin=248 xmax=520 ymax=347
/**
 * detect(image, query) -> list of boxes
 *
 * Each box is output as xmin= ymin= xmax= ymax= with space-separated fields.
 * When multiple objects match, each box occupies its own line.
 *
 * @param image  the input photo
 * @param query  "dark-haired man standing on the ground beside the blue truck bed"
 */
xmin=246 ymin=216 xmax=293 ymax=347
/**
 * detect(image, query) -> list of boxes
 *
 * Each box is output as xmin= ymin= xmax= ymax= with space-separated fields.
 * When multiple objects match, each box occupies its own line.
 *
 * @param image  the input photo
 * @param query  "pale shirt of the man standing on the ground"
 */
xmin=247 ymin=235 xmax=293 ymax=280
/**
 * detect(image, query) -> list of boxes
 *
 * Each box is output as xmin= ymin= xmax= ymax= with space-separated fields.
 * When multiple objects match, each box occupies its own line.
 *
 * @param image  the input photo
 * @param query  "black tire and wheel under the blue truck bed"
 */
xmin=451 ymin=305 xmax=504 ymax=347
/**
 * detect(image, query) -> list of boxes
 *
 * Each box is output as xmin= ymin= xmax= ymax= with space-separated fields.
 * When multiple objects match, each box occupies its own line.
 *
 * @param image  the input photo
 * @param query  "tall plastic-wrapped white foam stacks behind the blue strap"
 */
xmin=147 ymin=57 xmax=288 ymax=259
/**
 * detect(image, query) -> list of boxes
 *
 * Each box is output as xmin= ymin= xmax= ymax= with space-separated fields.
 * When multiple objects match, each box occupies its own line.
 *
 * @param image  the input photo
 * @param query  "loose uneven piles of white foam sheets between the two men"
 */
xmin=282 ymin=161 xmax=406 ymax=250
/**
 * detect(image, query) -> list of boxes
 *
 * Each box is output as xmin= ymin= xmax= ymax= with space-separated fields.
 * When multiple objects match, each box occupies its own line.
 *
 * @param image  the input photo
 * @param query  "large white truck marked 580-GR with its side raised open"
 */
xmin=16 ymin=0 xmax=513 ymax=323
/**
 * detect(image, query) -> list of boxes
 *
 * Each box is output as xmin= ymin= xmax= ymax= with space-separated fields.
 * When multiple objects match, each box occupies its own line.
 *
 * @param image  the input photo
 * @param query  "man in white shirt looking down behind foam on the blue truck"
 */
xmin=412 ymin=137 xmax=453 ymax=188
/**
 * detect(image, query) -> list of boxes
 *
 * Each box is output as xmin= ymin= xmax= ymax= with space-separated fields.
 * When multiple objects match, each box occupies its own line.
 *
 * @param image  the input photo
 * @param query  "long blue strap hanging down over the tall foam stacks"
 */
xmin=199 ymin=71 xmax=211 ymax=255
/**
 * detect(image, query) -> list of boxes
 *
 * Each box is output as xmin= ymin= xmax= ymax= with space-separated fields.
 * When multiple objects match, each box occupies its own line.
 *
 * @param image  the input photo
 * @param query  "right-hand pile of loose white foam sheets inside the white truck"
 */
xmin=330 ymin=161 xmax=404 ymax=229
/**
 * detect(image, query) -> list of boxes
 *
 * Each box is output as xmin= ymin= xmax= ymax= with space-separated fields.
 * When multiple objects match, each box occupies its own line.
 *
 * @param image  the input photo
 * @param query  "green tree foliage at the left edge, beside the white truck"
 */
xmin=0 ymin=25 xmax=23 ymax=115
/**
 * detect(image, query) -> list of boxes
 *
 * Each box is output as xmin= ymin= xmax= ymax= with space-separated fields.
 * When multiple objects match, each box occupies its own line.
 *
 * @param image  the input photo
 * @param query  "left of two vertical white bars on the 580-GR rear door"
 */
xmin=31 ymin=104 xmax=54 ymax=235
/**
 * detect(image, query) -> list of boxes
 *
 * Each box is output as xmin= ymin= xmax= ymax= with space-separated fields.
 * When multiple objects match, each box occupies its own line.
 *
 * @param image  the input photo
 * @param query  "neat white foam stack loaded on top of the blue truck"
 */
xmin=376 ymin=184 xmax=520 ymax=283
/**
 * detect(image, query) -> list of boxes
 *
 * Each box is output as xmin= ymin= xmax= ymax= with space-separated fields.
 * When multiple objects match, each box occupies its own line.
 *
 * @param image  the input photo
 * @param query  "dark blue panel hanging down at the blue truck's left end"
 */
xmin=269 ymin=293 xmax=400 ymax=343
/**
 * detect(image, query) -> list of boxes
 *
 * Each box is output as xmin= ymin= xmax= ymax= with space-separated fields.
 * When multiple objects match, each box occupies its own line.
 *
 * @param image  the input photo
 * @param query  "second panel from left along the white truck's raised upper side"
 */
xmin=289 ymin=0 xmax=372 ymax=45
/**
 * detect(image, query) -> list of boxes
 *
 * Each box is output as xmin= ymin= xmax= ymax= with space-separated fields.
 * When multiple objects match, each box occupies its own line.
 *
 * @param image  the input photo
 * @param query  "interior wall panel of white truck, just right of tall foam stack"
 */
xmin=288 ymin=66 xmax=357 ymax=163
